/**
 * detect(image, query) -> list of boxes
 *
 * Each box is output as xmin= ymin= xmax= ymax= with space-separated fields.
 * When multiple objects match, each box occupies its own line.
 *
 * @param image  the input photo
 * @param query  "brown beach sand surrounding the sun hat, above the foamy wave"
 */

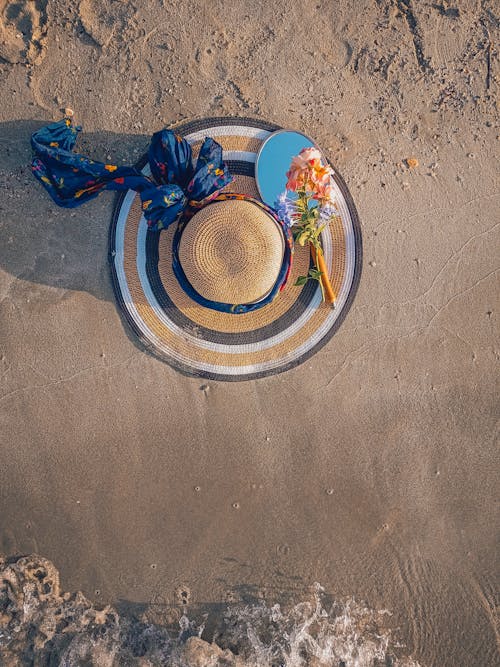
xmin=0 ymin=0 xmax=500 ymax=667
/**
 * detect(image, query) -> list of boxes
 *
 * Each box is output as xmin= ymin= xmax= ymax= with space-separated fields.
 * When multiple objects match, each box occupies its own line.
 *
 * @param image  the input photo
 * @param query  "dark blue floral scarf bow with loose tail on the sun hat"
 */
xmin=31 ymin=118 xmax=233 ymax=231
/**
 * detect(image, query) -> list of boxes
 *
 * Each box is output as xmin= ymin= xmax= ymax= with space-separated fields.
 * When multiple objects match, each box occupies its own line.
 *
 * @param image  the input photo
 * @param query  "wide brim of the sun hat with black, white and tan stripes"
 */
xmin=110 ymin=118 xmax=362 ymax=381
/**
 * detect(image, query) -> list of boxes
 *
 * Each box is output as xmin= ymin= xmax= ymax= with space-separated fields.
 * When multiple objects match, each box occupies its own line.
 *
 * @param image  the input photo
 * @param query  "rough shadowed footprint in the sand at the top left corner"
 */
xmin=0 ymin=0 xmax=47 ymax=65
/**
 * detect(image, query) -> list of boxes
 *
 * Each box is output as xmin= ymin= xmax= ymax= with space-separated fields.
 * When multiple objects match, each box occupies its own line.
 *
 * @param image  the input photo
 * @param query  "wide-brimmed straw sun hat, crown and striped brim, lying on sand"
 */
xmin=110 ymin=118 xmax=361 ymax=380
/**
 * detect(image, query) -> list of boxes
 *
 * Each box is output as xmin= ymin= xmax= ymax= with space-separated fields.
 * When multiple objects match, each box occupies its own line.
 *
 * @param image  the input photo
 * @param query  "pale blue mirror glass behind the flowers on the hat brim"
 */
xmin=255 ymin=130 xmax=316 ymax=208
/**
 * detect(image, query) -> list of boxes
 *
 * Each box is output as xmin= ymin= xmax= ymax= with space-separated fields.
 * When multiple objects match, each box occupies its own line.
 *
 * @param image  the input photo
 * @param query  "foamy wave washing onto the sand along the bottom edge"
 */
xmin=0 ymin=555 xmax=419 ymax=667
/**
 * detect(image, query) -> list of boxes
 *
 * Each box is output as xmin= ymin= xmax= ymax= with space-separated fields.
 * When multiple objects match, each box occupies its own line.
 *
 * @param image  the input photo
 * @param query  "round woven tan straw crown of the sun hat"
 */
xmin=179 ymin=200 xmax=284 ymax=304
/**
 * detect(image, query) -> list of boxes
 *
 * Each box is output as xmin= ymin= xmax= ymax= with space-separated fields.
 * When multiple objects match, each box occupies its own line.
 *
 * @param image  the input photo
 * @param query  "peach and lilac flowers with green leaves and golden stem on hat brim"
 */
xmin=275 ymin=148 xmax=338 ymax=304
